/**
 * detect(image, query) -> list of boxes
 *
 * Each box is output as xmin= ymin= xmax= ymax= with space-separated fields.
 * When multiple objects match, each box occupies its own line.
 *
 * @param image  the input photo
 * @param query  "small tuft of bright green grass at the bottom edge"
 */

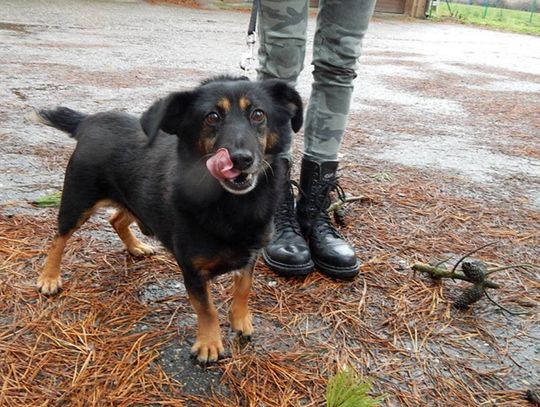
xmin=326 ymin=367 xmax=381 ymax=407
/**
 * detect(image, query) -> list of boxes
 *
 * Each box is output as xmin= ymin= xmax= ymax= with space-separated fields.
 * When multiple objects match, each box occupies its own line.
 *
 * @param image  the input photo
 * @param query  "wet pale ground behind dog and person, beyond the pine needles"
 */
xmin=0 ymin=0 xmax=540 ymax=207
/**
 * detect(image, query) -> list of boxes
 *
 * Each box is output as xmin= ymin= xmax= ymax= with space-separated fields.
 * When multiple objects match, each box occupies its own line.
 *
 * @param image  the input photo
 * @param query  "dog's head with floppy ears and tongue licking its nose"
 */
xmin=141 ymin=77 xmax=303 ymax=198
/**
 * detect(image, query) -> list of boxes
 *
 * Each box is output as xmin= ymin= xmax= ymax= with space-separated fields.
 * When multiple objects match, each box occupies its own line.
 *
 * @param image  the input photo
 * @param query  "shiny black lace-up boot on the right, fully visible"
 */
xmin=297 ymin=158 xmax=360 ymax=279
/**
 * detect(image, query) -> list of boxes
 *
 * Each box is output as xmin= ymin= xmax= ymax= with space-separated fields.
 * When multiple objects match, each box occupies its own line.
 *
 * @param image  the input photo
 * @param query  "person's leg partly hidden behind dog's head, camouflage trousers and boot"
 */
xmin=258 ymin=0 xmax=313 ymax=276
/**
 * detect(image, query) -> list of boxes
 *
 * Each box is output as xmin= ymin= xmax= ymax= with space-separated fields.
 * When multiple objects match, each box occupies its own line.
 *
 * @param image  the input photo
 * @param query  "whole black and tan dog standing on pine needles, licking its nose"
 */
xmin=38 ymin=77 xmax=303 ymax=363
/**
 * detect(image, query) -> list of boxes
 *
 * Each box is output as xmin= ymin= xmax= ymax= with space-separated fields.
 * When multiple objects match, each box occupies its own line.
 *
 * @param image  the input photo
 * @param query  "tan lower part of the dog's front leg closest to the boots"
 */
xmin=229 ymin=267 xmax=253 ymax=338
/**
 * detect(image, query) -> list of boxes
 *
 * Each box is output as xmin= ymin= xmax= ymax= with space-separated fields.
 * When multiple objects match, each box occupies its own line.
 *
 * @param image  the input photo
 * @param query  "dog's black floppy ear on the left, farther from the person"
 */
xmin=140 ymin=92 xmax=193 ymax=144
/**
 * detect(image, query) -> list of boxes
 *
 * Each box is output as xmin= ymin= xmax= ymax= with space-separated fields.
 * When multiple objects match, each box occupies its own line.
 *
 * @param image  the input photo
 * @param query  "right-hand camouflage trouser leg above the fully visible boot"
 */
xmin=304 ymin=0 xmax=375 ymax=163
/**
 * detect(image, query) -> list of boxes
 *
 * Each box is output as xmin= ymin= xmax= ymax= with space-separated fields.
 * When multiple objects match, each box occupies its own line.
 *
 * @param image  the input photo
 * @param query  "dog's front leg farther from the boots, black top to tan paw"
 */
xmin=182 ymin=268 xmax=224 ymax=364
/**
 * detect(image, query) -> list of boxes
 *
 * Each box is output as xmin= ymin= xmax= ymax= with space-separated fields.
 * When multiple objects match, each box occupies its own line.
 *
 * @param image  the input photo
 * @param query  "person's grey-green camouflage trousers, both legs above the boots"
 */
xmin=258 ymin=0 xmax=375 ymax=162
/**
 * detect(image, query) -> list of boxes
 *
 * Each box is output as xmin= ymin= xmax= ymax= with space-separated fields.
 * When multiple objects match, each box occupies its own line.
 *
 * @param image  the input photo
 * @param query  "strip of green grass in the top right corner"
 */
xmin=431 ymin=0 xmax=540 ymax=35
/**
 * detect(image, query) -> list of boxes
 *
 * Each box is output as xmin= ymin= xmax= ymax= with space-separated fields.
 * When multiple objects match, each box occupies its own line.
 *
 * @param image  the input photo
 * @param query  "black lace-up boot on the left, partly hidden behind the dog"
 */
xmin=262 ymin=163 xmax=314 ymax=277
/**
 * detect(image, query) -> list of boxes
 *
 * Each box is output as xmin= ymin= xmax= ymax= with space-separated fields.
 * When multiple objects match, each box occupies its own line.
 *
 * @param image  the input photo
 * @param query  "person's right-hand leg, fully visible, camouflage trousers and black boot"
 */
xmin=297 ymin=0 xmax=375 ymax=278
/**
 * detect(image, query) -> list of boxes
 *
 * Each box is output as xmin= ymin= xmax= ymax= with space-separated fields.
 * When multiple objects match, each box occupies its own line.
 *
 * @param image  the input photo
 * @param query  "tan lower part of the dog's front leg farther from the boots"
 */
xmin=188 ymin=282 xmax=225 ymax=363
